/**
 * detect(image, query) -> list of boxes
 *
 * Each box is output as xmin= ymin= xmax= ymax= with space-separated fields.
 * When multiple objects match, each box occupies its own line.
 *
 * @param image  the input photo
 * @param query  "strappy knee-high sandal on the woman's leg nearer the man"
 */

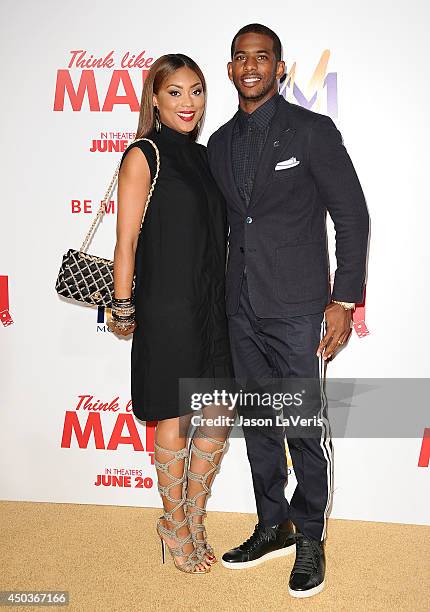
xmin=186 ymin=432 xmax=227 ymax=565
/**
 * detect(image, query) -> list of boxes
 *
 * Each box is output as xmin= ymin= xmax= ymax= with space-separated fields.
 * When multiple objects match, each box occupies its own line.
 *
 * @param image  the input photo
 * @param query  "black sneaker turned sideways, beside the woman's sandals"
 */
xmin=221 ymin=521 xmax=295 ymax=569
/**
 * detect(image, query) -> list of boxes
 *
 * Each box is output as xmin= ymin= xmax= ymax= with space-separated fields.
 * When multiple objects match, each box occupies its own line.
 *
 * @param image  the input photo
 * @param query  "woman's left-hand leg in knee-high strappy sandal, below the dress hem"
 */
xmin=155 ymin=417 xmax=208 ymax=572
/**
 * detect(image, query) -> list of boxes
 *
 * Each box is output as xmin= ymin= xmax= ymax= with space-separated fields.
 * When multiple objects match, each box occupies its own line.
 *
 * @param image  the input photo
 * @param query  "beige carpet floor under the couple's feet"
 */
xmin=0 ymin=501 xmax=430 ymax=612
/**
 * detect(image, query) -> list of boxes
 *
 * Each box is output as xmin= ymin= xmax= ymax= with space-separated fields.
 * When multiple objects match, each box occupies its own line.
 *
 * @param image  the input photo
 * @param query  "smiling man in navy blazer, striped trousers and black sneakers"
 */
xmin=208 ymin=24 xmax=369 ymax=597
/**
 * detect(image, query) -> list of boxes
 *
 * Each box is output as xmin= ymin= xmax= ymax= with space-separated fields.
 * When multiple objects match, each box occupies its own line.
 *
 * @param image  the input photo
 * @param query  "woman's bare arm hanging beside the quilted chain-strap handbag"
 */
xmin=114 ymin=147 xmax=151 ymax=299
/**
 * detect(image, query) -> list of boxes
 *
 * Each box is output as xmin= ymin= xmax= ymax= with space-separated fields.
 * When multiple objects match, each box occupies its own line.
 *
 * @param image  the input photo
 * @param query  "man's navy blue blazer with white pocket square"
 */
xmin=208 ymin=98 xmax=369 ymax=318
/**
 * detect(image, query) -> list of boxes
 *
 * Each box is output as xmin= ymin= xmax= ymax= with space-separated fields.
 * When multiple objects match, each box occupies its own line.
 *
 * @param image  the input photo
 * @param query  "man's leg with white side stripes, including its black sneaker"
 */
xmin=265 ymin=313 xmax=332 ymax=597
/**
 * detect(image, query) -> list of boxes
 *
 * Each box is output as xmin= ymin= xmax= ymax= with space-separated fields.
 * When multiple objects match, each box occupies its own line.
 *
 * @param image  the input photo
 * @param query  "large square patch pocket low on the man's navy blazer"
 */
xmin=275 ymin=240 xmax=329 ymax=304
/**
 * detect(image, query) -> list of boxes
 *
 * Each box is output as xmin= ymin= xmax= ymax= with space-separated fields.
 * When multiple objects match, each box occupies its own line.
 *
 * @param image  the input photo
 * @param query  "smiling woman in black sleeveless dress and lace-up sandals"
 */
xmin=109 ymin=54 xmax=232 ymax=573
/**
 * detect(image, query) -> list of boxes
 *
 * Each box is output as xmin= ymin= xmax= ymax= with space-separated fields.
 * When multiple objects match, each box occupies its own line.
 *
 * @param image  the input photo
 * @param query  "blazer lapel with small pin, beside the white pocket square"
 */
xmin=249 ymin=99 xmax=296 ymax=208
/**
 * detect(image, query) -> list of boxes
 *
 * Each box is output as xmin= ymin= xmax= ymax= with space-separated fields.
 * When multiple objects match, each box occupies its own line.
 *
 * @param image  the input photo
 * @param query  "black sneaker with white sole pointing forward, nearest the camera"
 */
xmin=288 ymin=533 xmax=325 ymax=597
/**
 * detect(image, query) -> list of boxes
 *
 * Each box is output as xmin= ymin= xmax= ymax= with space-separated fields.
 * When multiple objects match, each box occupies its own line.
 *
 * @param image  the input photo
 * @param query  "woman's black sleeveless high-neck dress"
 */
xmin=122 ymin=124 xmax=233 ymax=421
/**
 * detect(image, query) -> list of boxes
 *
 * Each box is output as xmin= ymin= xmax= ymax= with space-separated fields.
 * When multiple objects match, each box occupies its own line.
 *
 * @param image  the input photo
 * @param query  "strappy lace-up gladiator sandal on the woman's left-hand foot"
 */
xmin=154 ymin=443 xmax=210 ymax=574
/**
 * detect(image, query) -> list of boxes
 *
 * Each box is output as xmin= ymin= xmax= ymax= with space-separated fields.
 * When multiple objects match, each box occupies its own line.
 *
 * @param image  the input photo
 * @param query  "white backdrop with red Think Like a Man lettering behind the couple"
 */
xmin=0 ymin=0 xmax=430 ymax=523
